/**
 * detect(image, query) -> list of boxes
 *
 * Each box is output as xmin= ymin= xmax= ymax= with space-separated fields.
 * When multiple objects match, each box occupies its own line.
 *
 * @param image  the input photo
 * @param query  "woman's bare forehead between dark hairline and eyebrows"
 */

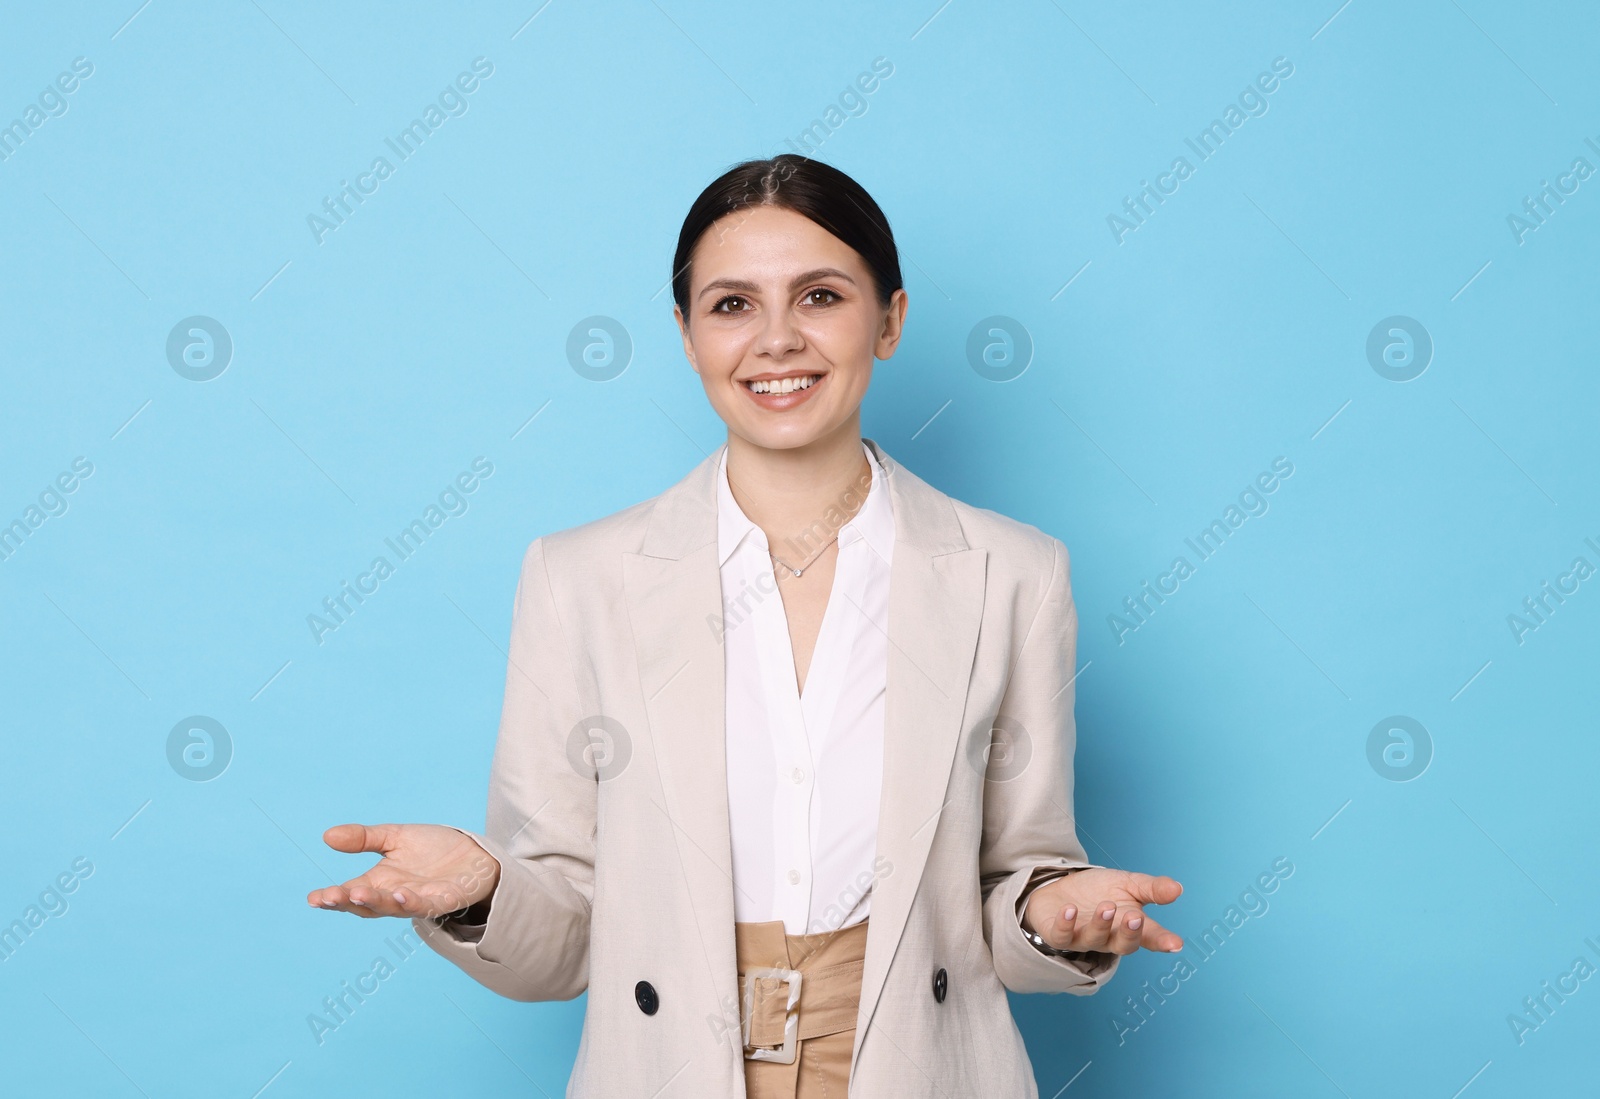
xmin=690 ymin=206 xmax=866 ymax=285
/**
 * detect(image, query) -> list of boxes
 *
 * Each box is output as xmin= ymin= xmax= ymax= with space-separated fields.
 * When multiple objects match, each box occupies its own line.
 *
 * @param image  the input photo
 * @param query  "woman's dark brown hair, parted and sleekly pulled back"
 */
xmin=672 ymin=152 xmax=904 ymax=320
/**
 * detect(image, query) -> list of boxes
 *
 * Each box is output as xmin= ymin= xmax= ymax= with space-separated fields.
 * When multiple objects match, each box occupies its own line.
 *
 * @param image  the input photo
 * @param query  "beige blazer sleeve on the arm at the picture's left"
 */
xmin=411 ymin=539 xmax=598 ymax=1000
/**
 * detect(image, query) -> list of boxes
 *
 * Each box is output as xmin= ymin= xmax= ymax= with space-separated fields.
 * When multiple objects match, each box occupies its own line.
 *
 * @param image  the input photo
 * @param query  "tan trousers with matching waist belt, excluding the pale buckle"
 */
xmin=734 ymin=920 xmax=867 ymax=1099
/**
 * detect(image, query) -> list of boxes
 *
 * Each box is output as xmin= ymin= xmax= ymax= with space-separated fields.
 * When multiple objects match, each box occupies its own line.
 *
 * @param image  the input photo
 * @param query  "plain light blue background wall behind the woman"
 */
xmin=0 ymin=0 xmax=1600 ymax=1099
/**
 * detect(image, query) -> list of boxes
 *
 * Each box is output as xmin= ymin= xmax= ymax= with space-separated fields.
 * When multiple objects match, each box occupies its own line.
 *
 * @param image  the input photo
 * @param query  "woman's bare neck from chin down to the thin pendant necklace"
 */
xmin=728 ymin=418 xmax=872 ymax=565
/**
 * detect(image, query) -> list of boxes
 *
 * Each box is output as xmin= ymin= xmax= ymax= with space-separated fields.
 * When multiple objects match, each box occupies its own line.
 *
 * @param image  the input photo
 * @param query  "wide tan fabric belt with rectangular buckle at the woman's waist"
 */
xmin=734 ymin=920 xmax=867 ymax=1064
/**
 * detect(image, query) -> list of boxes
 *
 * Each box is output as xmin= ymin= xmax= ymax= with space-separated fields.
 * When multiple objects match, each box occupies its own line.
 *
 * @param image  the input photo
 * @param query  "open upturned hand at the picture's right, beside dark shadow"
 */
xmin=1022 ymin=867 xmax=1184 ymax=953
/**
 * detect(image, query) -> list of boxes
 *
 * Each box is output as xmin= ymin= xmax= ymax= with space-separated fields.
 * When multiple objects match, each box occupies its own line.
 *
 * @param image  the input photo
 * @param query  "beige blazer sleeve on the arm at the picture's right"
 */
xmin=979 ymin=538 xmax=1120 ymax=995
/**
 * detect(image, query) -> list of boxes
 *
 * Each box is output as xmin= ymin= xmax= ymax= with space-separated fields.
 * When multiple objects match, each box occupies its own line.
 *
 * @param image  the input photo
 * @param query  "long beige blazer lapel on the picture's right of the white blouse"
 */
xmin=851 ymin=440 xmax=989 ymax=1065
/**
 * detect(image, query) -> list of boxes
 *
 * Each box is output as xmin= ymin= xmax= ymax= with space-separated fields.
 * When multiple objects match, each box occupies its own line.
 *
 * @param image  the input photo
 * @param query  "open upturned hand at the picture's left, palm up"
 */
xmin=306 ymin=824 xmax=499 ymax=918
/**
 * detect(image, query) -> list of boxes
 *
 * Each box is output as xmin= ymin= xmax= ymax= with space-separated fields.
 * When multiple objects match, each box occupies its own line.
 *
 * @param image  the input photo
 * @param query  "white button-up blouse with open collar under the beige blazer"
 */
xmin=717 ymin=443 xmax=894 ymax=934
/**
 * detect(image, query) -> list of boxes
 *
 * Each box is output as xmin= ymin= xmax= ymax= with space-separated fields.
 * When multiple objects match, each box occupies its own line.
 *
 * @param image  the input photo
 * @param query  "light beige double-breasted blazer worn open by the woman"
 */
xmin=414 ymin=440 xmax=1117 ymax=1099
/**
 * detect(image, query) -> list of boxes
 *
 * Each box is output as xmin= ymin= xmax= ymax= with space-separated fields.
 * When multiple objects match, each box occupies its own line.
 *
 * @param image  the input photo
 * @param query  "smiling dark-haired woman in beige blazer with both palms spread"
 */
xmin=307 ymin=155 xmax=1182 ymax=1099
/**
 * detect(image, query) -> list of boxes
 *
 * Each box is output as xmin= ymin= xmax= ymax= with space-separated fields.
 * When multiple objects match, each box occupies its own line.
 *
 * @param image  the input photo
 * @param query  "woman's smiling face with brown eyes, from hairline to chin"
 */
xmin=672 ymin=206 xmax=906 ymax=450
